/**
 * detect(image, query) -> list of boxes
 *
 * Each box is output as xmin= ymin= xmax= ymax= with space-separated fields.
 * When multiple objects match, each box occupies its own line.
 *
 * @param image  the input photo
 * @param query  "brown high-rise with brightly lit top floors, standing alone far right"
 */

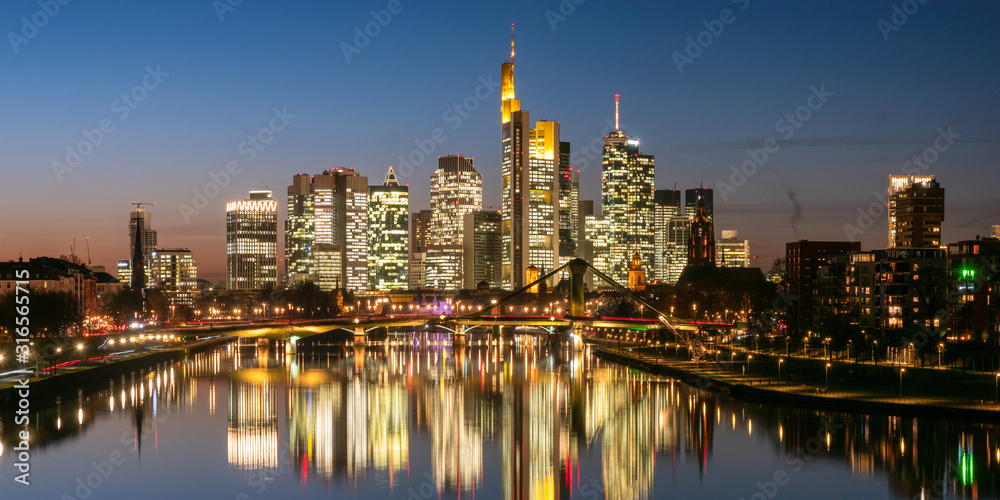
xmin=889 ymin=175 xmax=944 ymax=248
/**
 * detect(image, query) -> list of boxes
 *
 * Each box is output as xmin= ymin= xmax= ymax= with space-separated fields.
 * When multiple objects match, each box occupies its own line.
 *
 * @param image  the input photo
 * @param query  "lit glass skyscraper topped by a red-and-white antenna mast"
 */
xmin=601 ymin=94 xmax=656 ymax=283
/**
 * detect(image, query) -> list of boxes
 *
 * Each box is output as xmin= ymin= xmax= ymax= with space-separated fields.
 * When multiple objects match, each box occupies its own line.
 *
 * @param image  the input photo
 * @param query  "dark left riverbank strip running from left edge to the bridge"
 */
xmin=0 ymin=337 xmax=235 ymax=406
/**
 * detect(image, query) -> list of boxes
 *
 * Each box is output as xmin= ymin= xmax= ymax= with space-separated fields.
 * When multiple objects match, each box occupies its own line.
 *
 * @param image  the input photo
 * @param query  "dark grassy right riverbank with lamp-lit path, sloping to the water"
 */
xmin=594 ymin=348 xmax=1000 ymax=422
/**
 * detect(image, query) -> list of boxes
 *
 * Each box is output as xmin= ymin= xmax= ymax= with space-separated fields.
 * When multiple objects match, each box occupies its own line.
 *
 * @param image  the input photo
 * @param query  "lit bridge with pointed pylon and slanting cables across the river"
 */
xmin=181 ymin=259 xmax=705 ymax=355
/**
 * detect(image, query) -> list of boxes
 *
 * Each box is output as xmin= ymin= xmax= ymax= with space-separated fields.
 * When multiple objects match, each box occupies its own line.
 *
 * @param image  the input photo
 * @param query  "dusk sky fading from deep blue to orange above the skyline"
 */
xmin=0 ymin=0 xmax=1000 ymax=281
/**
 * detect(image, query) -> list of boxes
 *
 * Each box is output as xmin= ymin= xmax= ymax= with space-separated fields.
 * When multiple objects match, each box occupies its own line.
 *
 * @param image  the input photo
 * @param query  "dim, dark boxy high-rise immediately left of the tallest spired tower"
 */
xmin=462 ymin=210 xmax=501 ymax=290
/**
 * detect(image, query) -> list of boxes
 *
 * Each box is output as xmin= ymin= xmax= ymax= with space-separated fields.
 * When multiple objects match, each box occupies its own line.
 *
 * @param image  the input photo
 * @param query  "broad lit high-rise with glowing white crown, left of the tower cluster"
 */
xmin=226 ymin=191 xmax=278 ymax=290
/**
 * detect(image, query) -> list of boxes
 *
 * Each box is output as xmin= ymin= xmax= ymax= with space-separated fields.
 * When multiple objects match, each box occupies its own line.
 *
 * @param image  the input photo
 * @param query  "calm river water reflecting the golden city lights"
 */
xmin=0 ymin=337 xmax=1000 ymax=500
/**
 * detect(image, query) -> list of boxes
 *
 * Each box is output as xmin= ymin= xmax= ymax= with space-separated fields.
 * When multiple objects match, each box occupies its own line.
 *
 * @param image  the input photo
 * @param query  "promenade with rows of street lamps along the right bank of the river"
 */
xmin=595 ymin=346 xmax=1000 ymax=420
